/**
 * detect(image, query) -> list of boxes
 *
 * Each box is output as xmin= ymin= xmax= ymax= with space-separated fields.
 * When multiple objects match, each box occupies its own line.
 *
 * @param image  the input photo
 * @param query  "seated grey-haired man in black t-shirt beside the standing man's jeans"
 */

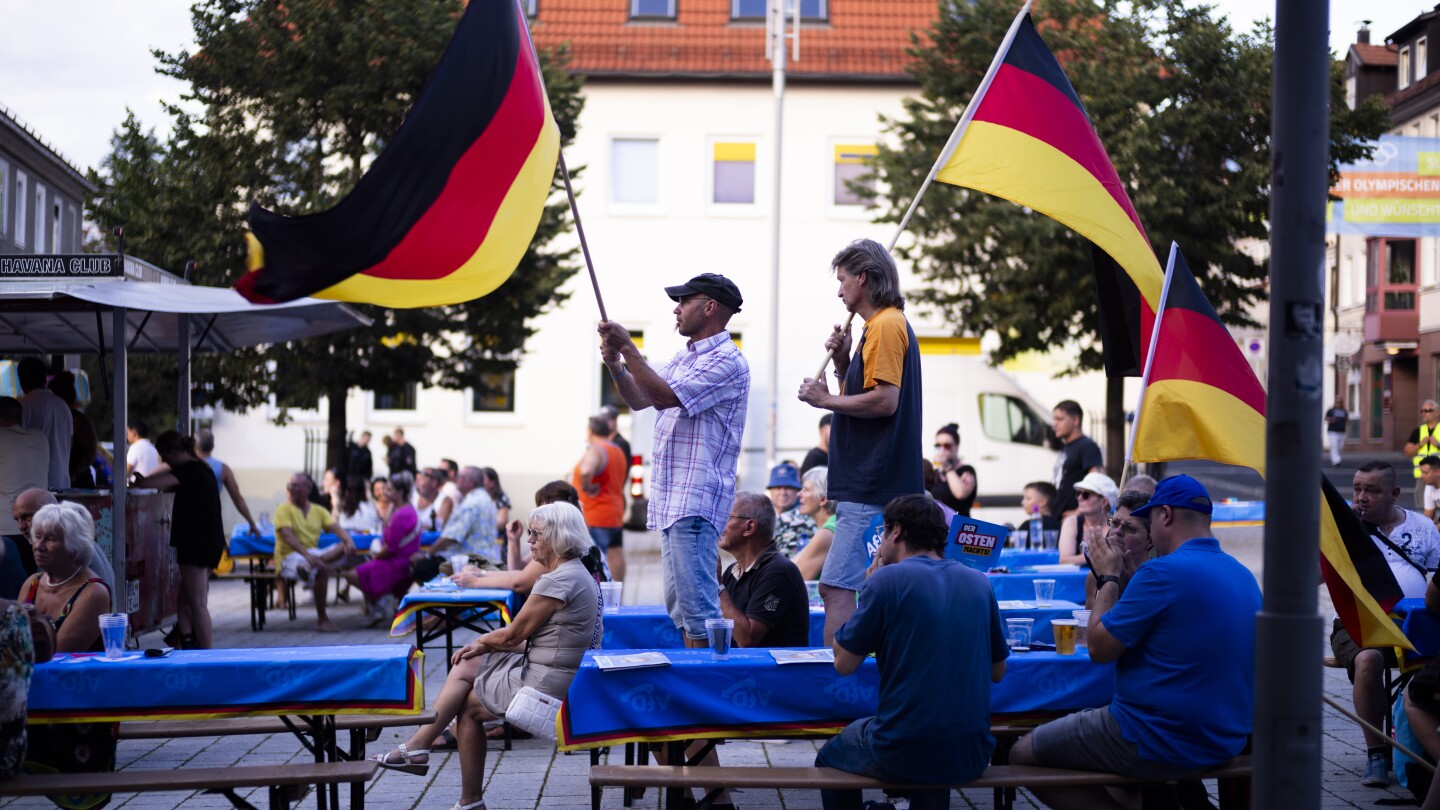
xmin=720 ymin=491 xmax=809 ymax=647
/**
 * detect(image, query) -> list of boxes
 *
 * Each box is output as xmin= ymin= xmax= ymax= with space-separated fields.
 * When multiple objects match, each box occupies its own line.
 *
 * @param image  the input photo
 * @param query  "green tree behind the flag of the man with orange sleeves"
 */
xmin=876 ymin=0 xmax=1387 ymax=468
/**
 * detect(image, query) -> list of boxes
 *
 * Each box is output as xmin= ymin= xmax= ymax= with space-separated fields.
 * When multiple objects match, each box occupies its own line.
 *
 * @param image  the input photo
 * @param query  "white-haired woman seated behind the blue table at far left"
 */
xmin=20 ymin=503 xmax=109 ymax=653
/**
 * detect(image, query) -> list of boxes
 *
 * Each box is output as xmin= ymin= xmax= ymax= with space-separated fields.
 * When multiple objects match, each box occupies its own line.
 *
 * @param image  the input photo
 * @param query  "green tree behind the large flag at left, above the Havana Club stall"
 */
xmin=91 ymin=0 xmax=583 ymax=464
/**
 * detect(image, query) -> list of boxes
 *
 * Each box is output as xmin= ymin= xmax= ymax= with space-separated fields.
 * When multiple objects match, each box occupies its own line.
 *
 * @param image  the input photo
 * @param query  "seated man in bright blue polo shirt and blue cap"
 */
xmin=1009 ymin=476 xmax=1260 ymax=809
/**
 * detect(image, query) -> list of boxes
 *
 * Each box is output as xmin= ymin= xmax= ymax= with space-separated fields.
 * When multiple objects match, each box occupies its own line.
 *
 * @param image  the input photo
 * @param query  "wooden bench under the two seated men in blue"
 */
xmin=590 ymin=755 xmax=1250 ymax=810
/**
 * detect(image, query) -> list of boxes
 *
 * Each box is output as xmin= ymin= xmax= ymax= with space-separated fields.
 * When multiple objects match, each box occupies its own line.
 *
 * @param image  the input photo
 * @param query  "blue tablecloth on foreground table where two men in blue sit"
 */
xmin=560 ymin=649 xmax=1115 ymax=749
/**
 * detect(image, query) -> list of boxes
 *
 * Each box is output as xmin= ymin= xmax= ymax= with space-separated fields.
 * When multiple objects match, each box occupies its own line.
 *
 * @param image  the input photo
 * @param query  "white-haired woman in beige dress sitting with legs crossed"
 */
xmin=372 ymin=503 xmax=603 ymax=810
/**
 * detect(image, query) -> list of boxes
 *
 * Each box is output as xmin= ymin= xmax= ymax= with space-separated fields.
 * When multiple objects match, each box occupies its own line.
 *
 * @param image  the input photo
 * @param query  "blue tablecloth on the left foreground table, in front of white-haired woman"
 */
xmin=29 ymin=644 xmax=425 ymax=724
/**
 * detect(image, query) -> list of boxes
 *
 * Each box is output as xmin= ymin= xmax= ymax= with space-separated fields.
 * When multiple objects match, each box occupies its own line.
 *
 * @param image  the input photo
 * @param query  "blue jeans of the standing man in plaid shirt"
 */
xmin=660 ymin=516 xmax=720 ymax=640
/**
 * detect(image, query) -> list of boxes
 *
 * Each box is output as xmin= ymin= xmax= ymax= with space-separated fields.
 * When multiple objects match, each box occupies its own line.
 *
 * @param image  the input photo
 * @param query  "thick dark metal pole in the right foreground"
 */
xmin=1251 ymin=0 xmax=1331 ymax=807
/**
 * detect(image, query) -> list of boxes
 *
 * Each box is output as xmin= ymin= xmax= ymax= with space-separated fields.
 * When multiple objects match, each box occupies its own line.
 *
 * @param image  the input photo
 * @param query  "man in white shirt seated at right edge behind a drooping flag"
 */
xmin=1331 ymin=461 xmax=1440 ymax=787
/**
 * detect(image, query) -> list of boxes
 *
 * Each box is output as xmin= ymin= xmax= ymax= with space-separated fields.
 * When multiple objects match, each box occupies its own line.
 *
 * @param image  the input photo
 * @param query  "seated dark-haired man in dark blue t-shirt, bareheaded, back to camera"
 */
xmin=815 ymin=494 xmax=1009 ymax=810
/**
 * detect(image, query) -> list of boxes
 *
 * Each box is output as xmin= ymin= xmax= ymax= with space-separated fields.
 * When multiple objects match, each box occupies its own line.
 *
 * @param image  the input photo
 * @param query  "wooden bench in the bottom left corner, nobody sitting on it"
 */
xmin=0 ymin=760 xmax=380 ymax=810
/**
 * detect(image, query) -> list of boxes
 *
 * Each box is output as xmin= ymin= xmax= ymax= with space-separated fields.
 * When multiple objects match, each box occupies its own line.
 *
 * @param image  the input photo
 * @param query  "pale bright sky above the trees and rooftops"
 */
xmin=0 ymin=0 xmax=1434 ymax=169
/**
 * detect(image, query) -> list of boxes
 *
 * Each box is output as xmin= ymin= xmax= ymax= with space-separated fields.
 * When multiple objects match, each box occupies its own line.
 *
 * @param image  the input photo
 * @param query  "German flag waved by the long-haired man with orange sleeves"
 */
xmin=935 ymin=13 xmax=1164 ymax=376
